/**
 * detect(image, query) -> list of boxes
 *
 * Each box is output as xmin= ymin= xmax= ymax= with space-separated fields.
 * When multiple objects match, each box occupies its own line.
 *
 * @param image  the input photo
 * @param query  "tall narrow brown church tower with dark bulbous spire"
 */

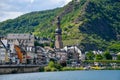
xmin=55 ymin=17 xmax=63 ymax=49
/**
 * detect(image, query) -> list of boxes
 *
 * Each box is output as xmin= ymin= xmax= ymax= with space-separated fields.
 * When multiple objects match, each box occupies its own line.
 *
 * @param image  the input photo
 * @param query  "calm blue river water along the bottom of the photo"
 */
xmin=0 ymin=70 xmax=120 ymax=80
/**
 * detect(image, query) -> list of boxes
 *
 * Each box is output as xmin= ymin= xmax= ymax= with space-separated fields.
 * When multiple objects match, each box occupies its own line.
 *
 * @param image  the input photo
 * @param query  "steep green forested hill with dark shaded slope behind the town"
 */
xmin=0 ymin=0 xmax=120 ymax=50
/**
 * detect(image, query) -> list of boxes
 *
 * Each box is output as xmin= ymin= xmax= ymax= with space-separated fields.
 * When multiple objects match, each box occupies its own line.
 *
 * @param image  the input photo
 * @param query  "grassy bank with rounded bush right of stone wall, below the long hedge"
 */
xmin=41 ymin=61 xmax=120 ymax=72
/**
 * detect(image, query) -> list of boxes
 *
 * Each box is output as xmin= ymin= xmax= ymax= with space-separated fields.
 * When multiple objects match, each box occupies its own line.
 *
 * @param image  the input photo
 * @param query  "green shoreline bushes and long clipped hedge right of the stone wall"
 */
xmin=40 ymin=60 xmax=120 ymax=72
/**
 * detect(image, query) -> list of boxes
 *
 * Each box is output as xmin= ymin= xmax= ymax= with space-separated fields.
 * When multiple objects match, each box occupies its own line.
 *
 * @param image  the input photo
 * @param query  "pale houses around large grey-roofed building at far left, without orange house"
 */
xmin=0 ymin=34 xmax=35 ymax=63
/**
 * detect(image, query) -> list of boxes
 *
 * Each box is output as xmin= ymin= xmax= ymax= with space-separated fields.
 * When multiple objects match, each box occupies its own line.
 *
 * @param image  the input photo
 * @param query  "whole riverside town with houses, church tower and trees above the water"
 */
xmin=0 ymin=17 xmax=120 ymax=74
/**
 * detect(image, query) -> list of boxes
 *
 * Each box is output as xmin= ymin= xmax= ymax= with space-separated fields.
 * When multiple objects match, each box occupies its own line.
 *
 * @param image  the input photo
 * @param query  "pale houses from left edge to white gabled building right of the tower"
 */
xmin=0 ymin=34 xmax=85 ymax=64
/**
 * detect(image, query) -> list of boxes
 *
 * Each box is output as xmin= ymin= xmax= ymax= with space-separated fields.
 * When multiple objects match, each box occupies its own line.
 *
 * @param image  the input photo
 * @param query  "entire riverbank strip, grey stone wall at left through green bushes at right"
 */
xmin=0 ymin=61 xmax=120 ymax=74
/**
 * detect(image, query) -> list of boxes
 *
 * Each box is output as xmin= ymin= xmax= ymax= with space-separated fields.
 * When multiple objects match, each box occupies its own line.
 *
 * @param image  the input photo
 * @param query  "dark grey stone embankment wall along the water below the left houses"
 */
xmin=0 ymin=64 xmax=44 ymax=74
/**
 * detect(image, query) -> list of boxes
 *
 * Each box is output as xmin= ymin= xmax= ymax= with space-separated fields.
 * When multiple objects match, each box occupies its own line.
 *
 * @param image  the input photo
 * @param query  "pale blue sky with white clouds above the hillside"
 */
xmin=0 ymin=0 xmax=72 ymax=22
